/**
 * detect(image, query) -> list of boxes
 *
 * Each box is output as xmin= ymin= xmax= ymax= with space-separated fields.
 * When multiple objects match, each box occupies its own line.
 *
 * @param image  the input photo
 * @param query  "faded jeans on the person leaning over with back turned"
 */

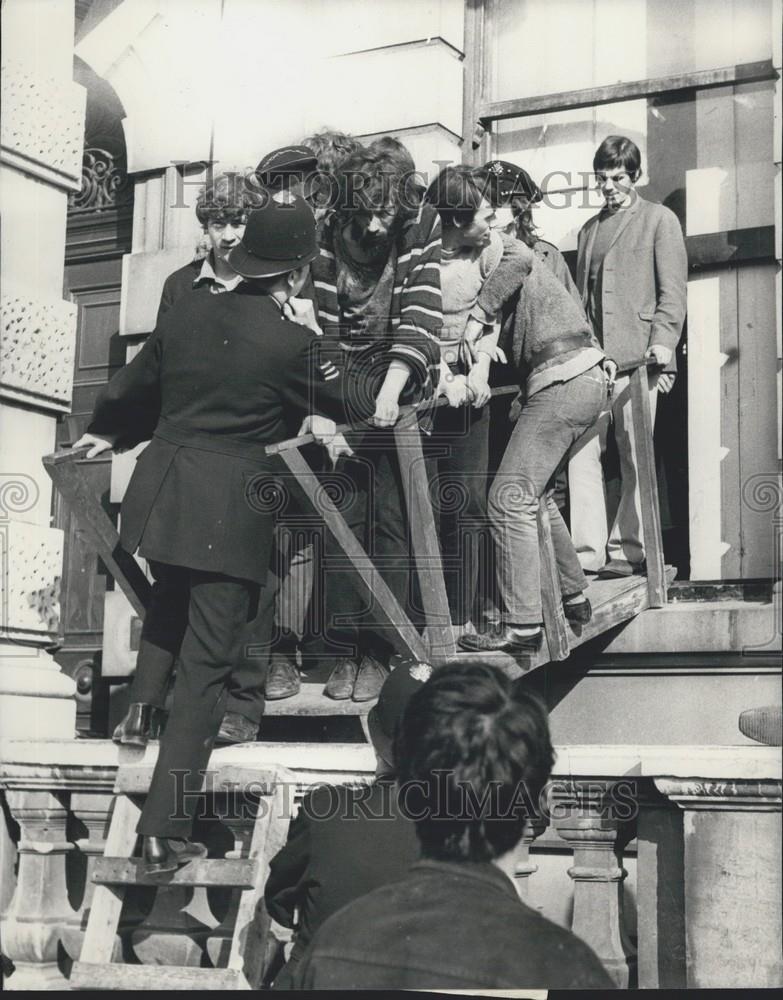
xmin=488 ymin=365 xmax=606 ymax=625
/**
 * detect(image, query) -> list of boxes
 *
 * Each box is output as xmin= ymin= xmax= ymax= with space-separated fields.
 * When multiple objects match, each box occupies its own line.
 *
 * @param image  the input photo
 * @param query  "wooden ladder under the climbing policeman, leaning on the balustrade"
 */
xmin=70 ymin=763 xmax=295 ymax=991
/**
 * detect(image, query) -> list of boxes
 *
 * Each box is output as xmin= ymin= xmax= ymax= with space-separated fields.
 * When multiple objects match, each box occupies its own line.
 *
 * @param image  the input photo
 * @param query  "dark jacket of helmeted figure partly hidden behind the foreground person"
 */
xmin=264 ymin=779 xmax=419 ymax=988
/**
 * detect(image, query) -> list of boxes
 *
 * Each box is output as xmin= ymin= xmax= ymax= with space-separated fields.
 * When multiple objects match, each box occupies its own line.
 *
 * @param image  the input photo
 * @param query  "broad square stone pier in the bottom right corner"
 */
xmin=655 ymin=777 xmax=783 ymax=989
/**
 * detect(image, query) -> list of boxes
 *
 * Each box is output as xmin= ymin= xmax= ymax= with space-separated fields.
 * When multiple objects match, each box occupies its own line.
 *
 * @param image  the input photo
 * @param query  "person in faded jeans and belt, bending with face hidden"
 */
xmin=460 ymin=250 xmax=616 ymax=654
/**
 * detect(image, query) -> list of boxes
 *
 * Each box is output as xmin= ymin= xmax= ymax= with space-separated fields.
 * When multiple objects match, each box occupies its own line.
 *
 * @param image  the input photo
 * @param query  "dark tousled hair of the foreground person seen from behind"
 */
xmin=394 ymin=660 xmax=554 ymax=861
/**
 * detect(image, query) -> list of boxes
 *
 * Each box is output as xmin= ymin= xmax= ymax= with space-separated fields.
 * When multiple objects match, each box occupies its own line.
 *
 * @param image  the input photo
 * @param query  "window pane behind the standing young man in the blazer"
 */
xmin=493 ymin=81 xmax=775 ymax=251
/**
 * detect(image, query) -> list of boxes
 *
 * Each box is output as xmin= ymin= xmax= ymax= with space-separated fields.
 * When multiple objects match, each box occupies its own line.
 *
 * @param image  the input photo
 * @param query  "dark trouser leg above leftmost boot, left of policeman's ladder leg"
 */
xmin=130 ymin=562 xmax=188 ymax=708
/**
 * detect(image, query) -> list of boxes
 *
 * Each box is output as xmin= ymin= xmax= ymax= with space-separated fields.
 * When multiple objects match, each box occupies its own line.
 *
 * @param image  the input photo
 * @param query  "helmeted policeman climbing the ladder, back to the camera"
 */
xmin=76 ymin=196 xmax=370 ymax=873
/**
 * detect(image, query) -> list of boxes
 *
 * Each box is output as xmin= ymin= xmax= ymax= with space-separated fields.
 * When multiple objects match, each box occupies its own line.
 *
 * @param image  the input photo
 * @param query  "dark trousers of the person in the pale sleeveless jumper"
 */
xmin=424 ymin=406 xmax=489 ymax=625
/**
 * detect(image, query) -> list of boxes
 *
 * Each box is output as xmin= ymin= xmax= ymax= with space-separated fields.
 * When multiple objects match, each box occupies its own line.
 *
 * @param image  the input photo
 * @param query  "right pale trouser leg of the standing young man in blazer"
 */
xmin=607 ymin=375 xmax=658 ymax=565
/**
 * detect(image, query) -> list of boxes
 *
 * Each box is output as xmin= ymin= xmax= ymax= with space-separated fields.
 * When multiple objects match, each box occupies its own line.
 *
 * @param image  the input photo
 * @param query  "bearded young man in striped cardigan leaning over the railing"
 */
xmin=313 ymin=149 xmax=443 ymax=701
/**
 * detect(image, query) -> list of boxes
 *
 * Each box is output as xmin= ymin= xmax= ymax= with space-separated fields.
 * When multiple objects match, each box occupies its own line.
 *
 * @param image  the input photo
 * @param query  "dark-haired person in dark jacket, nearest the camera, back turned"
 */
xmin=284 ymin=660 xmax=612 ymax=993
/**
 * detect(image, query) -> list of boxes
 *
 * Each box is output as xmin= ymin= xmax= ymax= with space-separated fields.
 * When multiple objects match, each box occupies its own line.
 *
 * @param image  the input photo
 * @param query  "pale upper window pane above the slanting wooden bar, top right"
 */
xmin=487 ymin=0 xmax=773 ymax=101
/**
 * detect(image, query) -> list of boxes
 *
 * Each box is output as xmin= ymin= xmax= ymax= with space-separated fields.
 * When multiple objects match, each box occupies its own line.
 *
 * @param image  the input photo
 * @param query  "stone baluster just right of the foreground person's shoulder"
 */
xmin=551 ymin=779 xmax=636 ymax=989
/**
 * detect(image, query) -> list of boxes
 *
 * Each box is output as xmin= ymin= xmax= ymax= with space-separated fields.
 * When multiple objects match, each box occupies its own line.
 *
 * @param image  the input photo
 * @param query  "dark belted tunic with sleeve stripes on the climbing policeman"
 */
xmin=89 ymin=284 xmax=362 ymax=583
